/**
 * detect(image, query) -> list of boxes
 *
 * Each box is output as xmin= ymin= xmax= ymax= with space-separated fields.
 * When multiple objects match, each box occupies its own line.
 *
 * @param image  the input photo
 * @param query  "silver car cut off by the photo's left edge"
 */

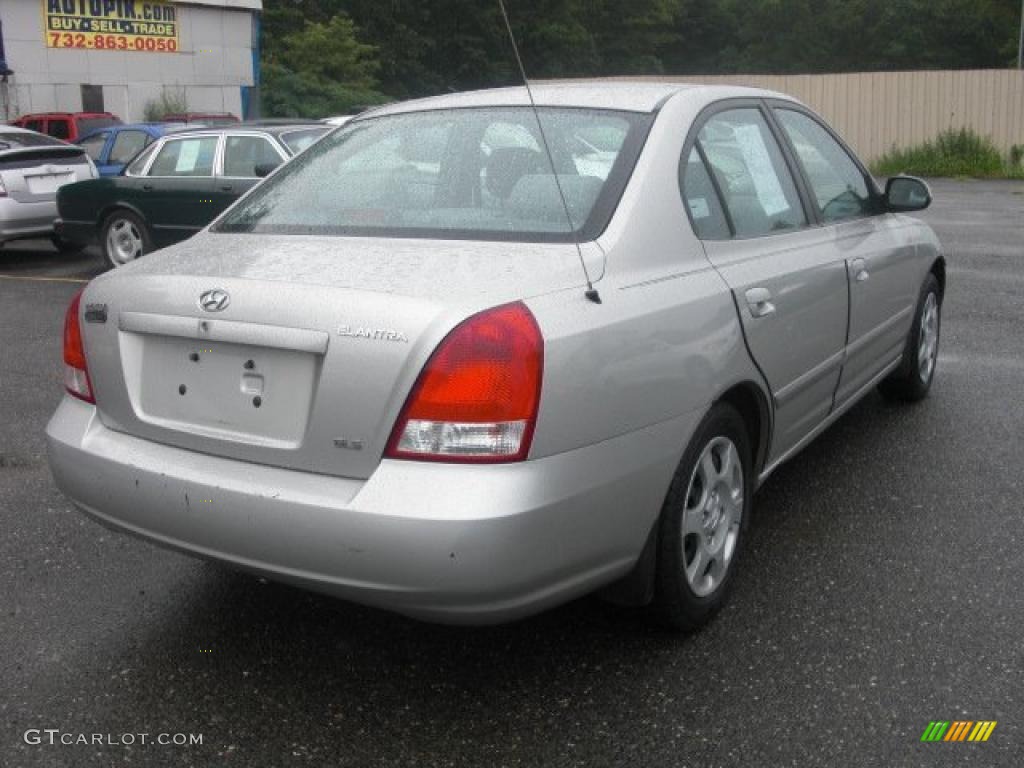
xmin=0 ymin=125 xmax=96 ymax=251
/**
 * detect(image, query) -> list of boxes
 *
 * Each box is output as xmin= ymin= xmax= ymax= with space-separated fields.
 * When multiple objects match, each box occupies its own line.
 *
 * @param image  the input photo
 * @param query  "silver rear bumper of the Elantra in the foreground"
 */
xmin=47 ymin=396 xmax=693 ymax=624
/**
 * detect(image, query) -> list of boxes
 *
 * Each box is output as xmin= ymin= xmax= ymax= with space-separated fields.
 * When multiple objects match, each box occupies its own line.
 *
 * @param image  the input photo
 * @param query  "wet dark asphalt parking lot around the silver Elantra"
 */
xmin=0 ymin=181 xmax=1024 ymax=768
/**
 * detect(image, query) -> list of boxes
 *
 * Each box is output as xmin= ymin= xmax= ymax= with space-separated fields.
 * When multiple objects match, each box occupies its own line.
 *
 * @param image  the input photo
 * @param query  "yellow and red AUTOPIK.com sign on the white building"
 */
xmin=42 ymin=0 xmax=178 ymax=53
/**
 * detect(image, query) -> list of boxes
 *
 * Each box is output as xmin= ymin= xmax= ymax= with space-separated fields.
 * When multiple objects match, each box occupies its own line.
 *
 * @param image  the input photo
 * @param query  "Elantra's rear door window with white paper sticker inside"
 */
xmin=697 ymin=108 xmax=807 ymax=238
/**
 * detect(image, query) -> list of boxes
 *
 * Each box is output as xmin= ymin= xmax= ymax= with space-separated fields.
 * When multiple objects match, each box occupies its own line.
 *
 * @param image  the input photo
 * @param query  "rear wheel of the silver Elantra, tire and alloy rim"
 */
xmin=655 ymin=403 xmax=754 ymax=631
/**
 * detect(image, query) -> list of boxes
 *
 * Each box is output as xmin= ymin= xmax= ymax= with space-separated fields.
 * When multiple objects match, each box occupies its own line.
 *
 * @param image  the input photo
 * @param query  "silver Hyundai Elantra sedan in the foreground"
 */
xmin=47 ymin=83 xmax=945 ymax=630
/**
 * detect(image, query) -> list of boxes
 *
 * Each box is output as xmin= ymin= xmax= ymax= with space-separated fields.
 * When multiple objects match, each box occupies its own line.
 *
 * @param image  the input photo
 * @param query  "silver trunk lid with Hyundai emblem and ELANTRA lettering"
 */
xmin=83 ymin=233 xmax=600 ymax=478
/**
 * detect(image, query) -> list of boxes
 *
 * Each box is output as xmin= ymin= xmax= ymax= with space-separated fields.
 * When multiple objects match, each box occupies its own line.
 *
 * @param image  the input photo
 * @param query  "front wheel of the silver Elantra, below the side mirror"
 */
xmin=879 ymin=274 xmax=942 ymax=402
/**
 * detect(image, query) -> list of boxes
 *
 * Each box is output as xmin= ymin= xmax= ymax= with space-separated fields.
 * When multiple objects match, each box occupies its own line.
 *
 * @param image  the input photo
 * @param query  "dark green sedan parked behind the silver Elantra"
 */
xmin=55 ymin=124 xmax=328 ymax=266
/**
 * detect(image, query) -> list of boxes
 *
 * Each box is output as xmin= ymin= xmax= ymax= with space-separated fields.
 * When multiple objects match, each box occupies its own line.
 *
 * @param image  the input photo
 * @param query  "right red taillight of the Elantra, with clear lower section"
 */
xmin=384 ymin=303 xmax=544 ymax=462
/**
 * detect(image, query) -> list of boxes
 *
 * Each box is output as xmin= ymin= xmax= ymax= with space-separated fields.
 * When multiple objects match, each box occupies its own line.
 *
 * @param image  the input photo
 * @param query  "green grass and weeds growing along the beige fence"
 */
xmin=871 ymin=128 xmax=1024 ymax=179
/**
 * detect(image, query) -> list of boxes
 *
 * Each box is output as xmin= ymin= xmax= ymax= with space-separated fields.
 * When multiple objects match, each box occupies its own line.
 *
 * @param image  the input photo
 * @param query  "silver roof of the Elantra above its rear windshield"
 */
xmin=364 ymin=80 xmax=790 ymax=120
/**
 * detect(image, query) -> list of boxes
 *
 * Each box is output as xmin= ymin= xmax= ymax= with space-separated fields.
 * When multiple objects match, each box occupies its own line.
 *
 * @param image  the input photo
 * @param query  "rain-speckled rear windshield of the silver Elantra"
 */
xmin=214 ymin=108 xmax=651 ymax=242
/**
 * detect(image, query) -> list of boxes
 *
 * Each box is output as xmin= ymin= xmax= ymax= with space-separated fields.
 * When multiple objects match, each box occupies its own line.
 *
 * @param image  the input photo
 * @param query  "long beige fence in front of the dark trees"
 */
xmin=593 ymin=70 xmax=1024 ymax=161
